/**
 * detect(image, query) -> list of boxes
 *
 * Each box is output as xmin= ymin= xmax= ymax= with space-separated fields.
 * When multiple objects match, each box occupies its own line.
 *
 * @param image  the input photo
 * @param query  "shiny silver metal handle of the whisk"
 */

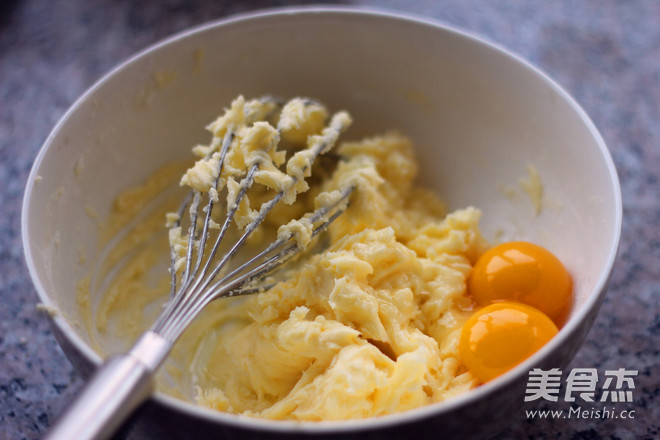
xmin=44 ymin=333 xmax=170 ymax=440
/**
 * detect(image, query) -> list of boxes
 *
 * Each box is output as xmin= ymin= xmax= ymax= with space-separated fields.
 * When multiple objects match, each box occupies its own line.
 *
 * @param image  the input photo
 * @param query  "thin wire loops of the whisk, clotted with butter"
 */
xmin=152 ymin=98 xmax=355 ymax=341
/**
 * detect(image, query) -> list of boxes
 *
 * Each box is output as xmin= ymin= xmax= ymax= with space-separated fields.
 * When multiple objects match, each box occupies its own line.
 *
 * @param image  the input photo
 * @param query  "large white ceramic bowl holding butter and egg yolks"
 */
xmin=23 ymin=8 xmax=622 ymax=438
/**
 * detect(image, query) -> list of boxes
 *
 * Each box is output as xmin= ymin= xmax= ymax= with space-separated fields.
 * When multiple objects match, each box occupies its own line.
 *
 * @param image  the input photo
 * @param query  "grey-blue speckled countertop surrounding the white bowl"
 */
xmin=0 ymin=0 xmax=660 ymax=440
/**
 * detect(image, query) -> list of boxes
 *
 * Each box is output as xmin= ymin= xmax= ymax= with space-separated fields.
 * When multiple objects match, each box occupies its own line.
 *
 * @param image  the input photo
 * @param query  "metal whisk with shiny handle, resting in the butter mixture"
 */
xmin=45 ymin=97 xmax=355 ymax=440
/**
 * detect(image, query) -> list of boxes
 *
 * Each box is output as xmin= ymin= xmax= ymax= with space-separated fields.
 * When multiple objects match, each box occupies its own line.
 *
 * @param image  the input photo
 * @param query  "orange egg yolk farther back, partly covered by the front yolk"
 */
xmin=468 ymin=241 xmax=573 ymax=325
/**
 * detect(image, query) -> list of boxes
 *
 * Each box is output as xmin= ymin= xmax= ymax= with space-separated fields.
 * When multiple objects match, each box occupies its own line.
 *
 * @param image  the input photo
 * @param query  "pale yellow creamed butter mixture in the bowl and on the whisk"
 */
xmin=89 ymin=98 xmax=486 ymax=421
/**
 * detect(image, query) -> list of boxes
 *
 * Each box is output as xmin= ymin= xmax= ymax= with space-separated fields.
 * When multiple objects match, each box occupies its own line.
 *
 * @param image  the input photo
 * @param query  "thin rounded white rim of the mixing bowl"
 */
xmin=21 ymin=5 xmax=623 ymax=434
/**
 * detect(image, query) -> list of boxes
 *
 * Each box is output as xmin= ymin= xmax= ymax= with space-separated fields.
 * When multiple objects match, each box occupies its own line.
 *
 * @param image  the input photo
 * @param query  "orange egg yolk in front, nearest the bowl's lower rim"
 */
xmin=459 ymin=302 xmax=557 ymax=382
